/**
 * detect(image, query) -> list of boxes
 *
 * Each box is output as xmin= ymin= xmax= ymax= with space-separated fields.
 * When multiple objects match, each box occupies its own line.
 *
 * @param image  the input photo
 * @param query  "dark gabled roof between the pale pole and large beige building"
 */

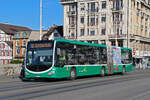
xmin=42 ymin=25 xmax=63 ymax=40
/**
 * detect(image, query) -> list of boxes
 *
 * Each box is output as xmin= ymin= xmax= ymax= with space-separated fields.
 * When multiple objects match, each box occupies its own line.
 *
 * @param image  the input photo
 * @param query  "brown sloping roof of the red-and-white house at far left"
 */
xmin=0 ymin=23 xmax=31 ymax=35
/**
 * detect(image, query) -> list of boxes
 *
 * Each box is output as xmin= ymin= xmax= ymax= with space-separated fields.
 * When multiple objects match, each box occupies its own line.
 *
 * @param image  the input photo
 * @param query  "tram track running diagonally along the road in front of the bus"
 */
xmin=0 ymin=71 xmax=150 ymax=100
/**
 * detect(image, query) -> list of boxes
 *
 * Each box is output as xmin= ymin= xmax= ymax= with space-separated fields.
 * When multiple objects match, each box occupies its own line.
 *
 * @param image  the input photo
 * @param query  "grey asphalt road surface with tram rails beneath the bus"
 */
xmin=0 ymin=70 xmax=150 ymax=100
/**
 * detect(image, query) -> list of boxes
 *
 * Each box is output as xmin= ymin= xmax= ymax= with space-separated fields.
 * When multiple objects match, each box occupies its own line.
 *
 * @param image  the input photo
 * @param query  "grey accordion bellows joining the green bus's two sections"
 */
xmin=107 ymin=46 xmax=113 ymax=74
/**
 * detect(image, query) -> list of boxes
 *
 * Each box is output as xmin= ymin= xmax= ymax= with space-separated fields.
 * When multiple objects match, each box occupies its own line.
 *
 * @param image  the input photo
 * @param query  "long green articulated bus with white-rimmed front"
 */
xmin=24 ymin=39 xmax=133 ymax=79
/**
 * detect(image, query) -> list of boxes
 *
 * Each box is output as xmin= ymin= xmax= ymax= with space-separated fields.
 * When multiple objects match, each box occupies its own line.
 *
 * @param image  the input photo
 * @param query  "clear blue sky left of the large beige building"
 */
xmin=0 ymin=0 xmax=63 ymax=30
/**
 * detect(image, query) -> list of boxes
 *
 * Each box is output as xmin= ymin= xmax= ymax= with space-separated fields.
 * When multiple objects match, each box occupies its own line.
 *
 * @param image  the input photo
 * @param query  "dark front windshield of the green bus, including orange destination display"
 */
xmin=26 ymin=42 xmax=53 ymax=72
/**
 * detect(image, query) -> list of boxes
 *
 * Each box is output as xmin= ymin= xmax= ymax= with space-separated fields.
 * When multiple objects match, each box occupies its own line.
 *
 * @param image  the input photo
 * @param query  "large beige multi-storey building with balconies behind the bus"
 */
xmin=60 ymin=0 xmax=150 ymax=57
